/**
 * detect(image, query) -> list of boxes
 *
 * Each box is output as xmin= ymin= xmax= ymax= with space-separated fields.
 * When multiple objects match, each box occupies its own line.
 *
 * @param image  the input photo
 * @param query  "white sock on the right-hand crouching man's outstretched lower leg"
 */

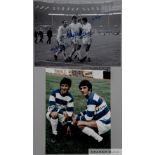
xmin=82 ymin=127 xmax=103 ymax=142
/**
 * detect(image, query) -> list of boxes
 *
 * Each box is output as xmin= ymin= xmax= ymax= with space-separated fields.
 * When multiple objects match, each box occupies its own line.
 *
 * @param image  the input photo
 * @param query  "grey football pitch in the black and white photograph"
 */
xmin=34 ymin=34 xmax=121 ymax=69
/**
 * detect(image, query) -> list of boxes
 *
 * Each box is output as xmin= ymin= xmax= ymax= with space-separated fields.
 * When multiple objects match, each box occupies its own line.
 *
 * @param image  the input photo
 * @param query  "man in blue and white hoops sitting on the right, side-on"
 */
xmin=74 ymin=80 xmax=111 ymax=142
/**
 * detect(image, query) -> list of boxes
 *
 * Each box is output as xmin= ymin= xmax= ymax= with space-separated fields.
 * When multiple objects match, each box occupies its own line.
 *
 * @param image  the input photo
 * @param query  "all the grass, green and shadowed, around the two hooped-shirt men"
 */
xmin=46 ymin=74 xmax=111 ymax=154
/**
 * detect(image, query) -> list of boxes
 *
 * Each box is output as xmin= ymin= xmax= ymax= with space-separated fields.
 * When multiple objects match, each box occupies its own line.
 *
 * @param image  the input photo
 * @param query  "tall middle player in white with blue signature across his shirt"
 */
xmin=68 ymin=16 xmax=82 ymax=61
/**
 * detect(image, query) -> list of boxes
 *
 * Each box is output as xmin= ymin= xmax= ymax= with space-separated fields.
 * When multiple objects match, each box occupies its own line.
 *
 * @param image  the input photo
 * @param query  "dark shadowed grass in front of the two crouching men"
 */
xmin=46 ymin=122 xmax=111 ymax=154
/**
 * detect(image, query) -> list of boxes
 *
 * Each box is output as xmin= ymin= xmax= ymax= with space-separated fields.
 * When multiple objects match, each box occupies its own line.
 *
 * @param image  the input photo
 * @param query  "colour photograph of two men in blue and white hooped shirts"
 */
xmin=45 ymin=68 xmax=111 ymax=154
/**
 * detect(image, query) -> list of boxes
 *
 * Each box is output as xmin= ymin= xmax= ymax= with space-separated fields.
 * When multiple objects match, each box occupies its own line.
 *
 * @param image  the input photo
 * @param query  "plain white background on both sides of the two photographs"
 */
xmin=0 ymin=0 xmax=155 ymax=155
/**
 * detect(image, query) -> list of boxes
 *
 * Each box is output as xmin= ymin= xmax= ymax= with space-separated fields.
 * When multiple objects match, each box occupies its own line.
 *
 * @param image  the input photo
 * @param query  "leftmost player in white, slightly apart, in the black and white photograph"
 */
xmin=54 ymin=20 xmax=68 ymax=61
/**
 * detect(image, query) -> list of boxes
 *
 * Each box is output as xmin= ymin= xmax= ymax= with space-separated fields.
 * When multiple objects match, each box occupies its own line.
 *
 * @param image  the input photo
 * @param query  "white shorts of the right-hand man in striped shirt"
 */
xmin=96 ymin=120 xmax=111 ymax=135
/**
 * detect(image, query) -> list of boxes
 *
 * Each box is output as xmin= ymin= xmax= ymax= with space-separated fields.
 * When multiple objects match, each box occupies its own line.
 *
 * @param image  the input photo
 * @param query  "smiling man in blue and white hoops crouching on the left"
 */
xmin=46 ymin=78 xmax=74 ymax=143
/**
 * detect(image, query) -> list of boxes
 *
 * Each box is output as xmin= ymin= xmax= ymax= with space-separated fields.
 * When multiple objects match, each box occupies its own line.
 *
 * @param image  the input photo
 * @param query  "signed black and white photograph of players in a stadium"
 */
xmin=34 ymin=0 xmax=122 ymax=68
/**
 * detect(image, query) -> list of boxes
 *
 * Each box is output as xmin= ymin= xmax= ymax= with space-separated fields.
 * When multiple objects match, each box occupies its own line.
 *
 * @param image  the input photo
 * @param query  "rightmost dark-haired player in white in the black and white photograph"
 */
xmin=80 ymin=17 xmax=92 ymax=62
